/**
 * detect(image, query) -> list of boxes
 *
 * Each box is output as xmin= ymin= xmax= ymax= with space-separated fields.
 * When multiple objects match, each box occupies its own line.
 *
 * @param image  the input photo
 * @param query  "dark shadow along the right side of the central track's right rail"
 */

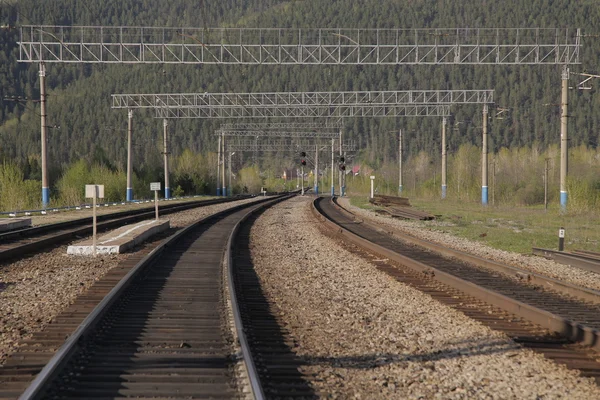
xmin=233 ymin=211 xmax=318 ymax=399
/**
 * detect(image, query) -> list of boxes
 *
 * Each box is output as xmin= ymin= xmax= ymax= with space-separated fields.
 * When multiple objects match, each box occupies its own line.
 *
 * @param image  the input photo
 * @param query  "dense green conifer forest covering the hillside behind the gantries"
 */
xmin=0 ymin=0 xmax=600 ymax=209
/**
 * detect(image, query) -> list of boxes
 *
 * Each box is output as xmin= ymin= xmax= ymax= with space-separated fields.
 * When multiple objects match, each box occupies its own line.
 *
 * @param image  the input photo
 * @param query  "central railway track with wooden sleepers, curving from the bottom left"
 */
xmin=0 ymin=196 xmax=310 ymax=399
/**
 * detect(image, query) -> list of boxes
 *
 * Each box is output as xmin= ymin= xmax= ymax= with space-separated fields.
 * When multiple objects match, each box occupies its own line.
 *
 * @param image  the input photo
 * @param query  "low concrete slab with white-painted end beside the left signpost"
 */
xmin=67 ymin=220 xmax=169 ymax=256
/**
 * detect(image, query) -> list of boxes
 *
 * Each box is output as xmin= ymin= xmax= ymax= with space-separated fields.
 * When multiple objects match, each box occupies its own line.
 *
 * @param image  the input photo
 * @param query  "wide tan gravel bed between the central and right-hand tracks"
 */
xmin=251 ymin=197 xmax=600 ymax=399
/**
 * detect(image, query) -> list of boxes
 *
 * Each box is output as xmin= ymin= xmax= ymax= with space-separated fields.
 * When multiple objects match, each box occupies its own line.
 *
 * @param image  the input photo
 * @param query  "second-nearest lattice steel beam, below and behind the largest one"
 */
xmin=112 ymin=89 xmax=494 ymax=109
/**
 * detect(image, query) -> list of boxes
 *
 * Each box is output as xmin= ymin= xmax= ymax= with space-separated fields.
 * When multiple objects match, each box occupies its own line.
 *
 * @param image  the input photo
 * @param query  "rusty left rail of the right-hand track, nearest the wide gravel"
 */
xmin=312 ymin=198 xmax=600 ymax=350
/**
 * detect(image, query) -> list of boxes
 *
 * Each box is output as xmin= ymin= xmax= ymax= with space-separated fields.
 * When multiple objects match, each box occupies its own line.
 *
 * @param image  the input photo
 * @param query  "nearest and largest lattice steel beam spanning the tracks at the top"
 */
xmin=18 ymin=25 xmax=581 ymax=65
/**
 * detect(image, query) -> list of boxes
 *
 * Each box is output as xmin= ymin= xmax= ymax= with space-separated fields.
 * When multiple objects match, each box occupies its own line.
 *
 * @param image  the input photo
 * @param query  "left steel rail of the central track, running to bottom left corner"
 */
xmin=19 ymin=198 xmax=288 ymax=400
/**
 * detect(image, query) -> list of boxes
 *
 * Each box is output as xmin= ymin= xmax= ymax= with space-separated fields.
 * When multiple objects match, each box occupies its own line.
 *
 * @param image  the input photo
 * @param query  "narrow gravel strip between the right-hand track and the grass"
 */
xmin=339 ymin=198 xmax=600 ymax=290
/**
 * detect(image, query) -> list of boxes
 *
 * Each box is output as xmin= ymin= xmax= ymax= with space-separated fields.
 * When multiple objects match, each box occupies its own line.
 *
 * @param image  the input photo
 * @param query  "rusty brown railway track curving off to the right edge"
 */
xmin=314 ymin=198 xmax=600 ymax=383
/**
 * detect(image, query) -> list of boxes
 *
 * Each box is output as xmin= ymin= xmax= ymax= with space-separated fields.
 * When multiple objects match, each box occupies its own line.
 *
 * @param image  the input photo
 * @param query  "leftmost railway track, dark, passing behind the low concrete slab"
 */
xmin=0 ymin=198 xmax=245 ymax=265
